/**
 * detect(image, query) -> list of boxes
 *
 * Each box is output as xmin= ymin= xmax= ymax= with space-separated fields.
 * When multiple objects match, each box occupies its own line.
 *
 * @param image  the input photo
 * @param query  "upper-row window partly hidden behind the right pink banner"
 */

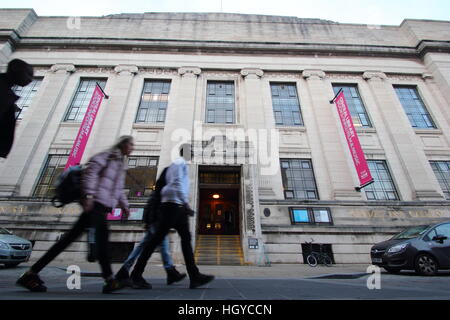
xmin=333 ymin=84 xmax=372 ymax=128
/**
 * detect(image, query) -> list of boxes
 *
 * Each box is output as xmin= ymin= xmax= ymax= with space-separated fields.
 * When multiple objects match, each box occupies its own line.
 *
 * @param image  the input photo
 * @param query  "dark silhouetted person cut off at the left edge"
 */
xmin=0 ymin=59 xmax=34 ymax=158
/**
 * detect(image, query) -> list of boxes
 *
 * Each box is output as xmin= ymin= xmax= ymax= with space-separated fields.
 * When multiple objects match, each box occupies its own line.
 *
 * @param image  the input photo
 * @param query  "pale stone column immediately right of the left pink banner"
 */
xmin=82 ymin=65 xmax=138 ymax=156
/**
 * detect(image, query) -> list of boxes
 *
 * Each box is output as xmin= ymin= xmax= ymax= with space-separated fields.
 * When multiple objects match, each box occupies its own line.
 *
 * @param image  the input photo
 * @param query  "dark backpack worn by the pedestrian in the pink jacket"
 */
xmin=51 ymin=165 xmax=83 ymax=208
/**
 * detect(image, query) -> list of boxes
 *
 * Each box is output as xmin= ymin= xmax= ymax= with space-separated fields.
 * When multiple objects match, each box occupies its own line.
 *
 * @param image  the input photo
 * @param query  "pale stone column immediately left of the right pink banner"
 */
xmin=302 ymin=70 xmax=361 ymax=200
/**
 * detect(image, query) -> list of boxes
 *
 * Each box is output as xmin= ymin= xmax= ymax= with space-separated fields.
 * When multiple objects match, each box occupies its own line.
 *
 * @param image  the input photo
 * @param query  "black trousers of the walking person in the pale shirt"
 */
xmin=131 ymin=202 xmax=199 ymax=279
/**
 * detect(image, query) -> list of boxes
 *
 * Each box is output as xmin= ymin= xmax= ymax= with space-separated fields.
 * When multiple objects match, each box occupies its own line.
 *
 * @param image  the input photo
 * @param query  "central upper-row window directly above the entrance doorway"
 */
xmin=206 ymin=81 xmax=235 ymax=123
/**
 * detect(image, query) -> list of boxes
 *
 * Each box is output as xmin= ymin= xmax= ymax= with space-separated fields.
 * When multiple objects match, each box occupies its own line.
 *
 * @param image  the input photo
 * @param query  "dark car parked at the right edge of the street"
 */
xmin=370 ymin=222 xmax=450 ymax=276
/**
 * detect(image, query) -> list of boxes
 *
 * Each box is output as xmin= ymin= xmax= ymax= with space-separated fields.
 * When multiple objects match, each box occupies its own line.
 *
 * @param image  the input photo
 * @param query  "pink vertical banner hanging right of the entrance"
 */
xmin=334 ymin=90 xmax=373 ymax=189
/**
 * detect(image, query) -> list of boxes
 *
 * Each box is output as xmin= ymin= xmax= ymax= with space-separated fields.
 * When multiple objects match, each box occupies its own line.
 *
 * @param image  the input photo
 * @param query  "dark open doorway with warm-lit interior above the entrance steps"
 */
xmin=198 ymin=188 xmax=239 ymax=235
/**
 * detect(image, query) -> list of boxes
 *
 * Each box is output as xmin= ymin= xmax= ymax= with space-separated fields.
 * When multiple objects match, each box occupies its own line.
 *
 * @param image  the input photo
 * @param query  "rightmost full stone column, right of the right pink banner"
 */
xmin=363 ymin=71 xmax=443 ymax=200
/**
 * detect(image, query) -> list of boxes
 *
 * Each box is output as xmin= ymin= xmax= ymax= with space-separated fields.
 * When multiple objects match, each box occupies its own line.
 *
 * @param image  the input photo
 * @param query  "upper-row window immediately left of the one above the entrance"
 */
xmin=135 ymin=80 xmax=170 ymax=123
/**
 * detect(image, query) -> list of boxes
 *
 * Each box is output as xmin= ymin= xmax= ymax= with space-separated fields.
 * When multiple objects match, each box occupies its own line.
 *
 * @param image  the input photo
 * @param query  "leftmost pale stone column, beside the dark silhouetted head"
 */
xmin=0 ymin=64 xmax=75 ymax=196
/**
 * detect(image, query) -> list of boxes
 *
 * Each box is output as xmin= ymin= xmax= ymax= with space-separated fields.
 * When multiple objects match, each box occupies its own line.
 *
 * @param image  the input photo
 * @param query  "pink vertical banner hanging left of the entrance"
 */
xmin=64 ymin=84 xmax=105 ymax=170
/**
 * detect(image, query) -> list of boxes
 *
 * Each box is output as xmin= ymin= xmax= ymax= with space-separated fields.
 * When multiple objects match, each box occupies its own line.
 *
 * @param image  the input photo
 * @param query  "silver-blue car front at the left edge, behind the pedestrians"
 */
xmin=0 ymin=228 xmax=32 ymax=267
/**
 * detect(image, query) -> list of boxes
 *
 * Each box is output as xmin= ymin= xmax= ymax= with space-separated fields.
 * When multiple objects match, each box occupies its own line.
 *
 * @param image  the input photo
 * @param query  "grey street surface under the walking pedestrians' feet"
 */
xmin=0 ymin=260 xmax=450 ymax=301
